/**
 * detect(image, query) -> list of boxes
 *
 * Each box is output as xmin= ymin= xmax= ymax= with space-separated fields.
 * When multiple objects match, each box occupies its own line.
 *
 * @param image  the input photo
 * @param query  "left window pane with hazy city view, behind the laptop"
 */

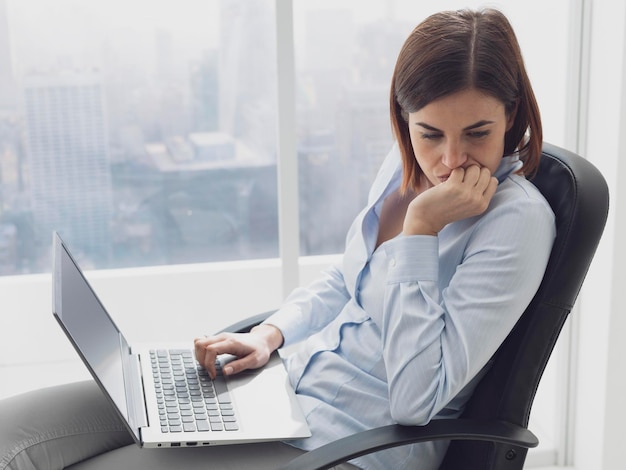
xmin=0 ymin=0 xmax=278 ymax=275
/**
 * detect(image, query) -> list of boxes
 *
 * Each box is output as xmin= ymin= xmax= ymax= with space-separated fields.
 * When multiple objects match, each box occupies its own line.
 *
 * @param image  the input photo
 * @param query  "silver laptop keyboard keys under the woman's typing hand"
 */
xmin=150 ymin=349 xmax=239 ymax=433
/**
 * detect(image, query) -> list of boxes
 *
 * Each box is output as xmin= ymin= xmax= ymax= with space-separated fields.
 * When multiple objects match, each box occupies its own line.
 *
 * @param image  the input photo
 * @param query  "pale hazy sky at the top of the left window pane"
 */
xmin=6 ymin=0 xmax=219 ymax=73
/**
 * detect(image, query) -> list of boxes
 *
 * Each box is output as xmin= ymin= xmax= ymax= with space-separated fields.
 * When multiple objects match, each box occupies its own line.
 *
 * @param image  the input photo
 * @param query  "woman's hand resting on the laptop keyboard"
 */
xmin=194 ymin=324 xmax=283 ymax=378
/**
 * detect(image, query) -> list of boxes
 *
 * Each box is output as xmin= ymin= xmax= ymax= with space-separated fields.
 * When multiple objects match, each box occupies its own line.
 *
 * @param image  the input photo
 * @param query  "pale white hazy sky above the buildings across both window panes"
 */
xmin=0 ymin=0 xmax=571 ymax=146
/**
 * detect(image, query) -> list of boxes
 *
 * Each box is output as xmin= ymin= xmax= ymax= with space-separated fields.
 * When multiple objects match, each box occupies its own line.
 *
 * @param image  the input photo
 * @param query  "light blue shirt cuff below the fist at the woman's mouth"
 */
xmin=385 ymin=235 xmax=439 ymax=284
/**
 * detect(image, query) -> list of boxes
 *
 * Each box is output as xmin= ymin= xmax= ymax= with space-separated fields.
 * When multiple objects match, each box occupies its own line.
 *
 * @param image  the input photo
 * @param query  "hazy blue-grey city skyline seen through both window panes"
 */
xmin=0 ymin=0 xmax=420 ymax=274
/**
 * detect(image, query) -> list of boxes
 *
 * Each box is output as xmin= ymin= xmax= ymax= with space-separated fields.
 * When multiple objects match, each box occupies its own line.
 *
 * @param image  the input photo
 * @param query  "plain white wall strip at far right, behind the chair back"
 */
xmin=571 ymin=0 xmax=626 ymax=470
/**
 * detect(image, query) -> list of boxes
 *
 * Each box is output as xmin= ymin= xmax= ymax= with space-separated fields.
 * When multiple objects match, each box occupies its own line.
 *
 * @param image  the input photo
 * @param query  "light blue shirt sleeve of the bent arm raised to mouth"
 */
xmin=381 ymin=193 xmax=555 ymax=425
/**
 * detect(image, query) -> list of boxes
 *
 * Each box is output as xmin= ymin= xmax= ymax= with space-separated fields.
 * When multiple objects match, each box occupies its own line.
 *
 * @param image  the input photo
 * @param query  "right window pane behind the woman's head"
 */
xmin=293 ymin=0 xmax=569 ymax=255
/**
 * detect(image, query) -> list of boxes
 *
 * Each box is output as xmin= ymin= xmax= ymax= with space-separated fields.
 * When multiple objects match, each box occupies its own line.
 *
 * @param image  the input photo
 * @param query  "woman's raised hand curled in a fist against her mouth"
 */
xmin=402 ymin=165 xmax=498 ymax=236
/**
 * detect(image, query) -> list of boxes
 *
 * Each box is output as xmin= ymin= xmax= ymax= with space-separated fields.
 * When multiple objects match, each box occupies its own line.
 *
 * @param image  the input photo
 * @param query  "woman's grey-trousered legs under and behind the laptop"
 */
xmin=0 ymin=381 xmax=356 ymax=470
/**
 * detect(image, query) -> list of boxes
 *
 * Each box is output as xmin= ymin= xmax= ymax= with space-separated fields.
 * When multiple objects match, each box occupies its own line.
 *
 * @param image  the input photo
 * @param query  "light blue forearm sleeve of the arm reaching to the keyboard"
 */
xmin=264 ymin=266 xmax=350 ymax=347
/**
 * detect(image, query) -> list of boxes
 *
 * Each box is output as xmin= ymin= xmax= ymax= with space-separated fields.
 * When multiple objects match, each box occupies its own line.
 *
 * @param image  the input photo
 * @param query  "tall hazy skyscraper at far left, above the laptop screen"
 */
xmin=24 ymin=73 xmax=112 ymax=261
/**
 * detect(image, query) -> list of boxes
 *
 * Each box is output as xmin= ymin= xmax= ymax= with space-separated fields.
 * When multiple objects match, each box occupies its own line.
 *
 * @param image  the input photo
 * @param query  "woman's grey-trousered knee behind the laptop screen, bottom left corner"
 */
xmin=0 ymin=381 xmax=133 ymax=470
